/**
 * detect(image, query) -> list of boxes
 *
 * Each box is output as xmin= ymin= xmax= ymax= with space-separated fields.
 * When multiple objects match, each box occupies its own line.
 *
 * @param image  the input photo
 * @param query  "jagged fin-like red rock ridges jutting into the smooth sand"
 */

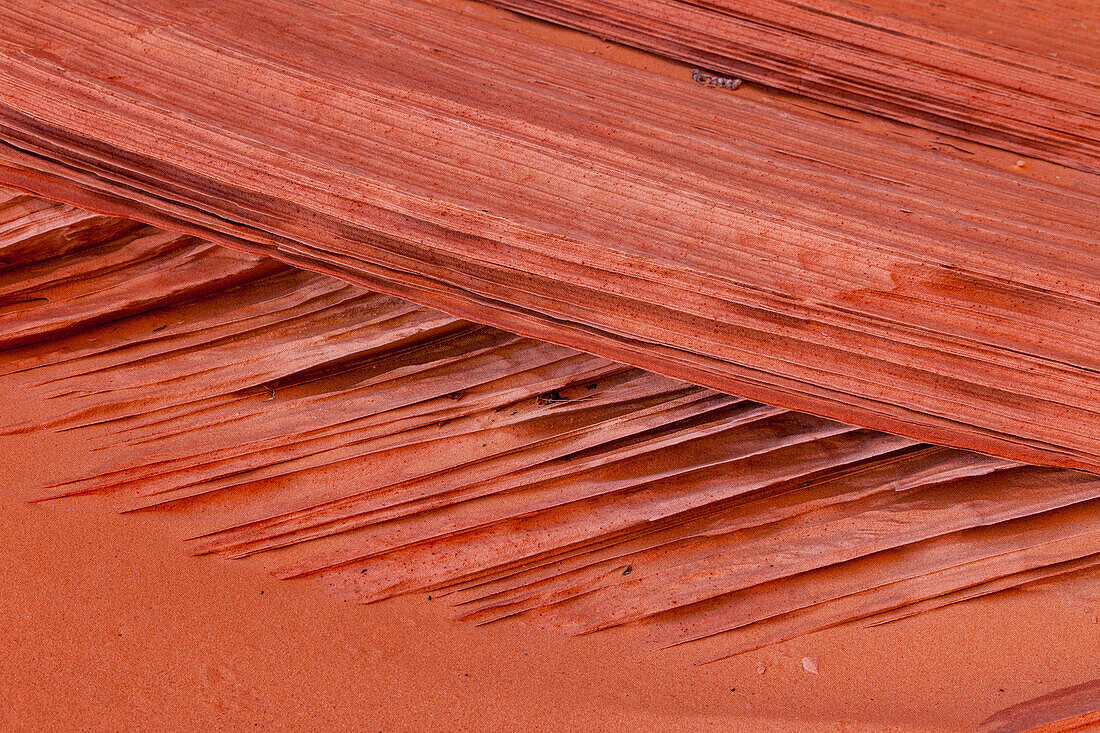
xmin=8 ymin=192 xmax=1100 ymax=658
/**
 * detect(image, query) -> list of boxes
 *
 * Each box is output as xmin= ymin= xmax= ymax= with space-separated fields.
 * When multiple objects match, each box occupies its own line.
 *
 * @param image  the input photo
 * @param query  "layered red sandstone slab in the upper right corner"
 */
xmin=488 ymin=0 xmax=1100 ymax=173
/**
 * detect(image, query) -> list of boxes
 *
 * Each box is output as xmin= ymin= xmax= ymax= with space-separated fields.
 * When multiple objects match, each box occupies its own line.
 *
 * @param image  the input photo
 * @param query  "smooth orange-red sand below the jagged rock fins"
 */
xmin=0 ymin=385 xmax=1100 ymax=731
